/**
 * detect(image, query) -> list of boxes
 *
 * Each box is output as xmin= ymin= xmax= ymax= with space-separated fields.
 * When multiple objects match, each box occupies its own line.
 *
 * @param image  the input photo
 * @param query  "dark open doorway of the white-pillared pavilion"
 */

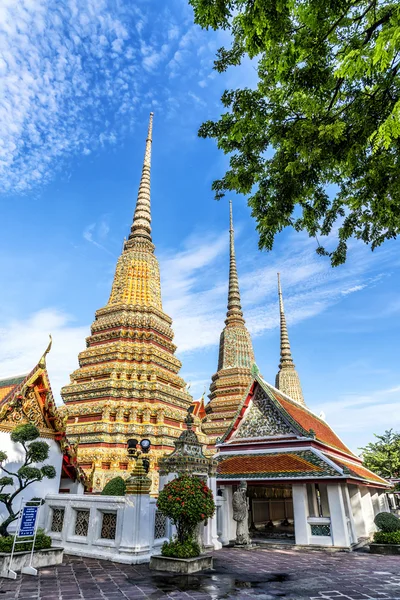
xmin=248 ymin=484 xmax=294 ymax=541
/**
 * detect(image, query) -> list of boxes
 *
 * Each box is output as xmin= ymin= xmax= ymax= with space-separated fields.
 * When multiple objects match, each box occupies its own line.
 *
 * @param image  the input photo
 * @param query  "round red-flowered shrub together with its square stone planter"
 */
xmin=150 ymin=475 xmax=215 ymax=573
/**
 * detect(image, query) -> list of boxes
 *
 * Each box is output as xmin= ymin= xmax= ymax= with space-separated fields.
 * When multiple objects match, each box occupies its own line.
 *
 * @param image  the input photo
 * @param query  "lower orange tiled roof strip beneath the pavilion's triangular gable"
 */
xmin=217 ymin=452 xmax=323 ymax=475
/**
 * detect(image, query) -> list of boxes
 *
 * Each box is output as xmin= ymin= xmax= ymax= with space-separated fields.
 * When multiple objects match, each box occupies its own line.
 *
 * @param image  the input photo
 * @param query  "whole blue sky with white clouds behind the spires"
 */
xmin=0 ymin=0 xmax=400 ymax=449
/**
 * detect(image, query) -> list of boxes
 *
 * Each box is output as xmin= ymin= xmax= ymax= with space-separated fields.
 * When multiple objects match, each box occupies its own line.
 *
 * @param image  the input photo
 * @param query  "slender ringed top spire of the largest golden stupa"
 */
xmin=129 ymin=112 xmax=154 ymax=241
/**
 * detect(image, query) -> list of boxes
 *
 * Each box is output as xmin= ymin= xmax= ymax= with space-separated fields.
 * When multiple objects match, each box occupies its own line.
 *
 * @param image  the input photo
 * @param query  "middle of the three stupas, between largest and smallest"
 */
xmin=202 ymin=202 xmax=254 ymax=445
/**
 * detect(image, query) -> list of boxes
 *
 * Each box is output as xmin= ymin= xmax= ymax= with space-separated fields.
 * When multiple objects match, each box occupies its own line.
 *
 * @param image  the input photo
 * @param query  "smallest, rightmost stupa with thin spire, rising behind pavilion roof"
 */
xmin=275 ymin=273 xmax=305 ymax=405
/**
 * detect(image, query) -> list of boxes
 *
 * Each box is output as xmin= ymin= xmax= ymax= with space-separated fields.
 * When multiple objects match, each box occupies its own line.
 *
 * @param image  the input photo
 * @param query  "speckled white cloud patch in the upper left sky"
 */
xmin=0 ymin=0 xmax=219 ymax=193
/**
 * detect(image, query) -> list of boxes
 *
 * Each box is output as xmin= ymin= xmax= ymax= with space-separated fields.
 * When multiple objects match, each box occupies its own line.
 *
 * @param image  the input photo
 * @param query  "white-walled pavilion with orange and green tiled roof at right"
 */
xmin=216 ymin=367 xmax=390 ymax=549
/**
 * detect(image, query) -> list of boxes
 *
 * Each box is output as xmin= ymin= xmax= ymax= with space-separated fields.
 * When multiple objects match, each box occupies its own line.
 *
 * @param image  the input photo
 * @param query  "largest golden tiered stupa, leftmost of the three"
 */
xmin=61 ymin=113 xmax=192 ymax=491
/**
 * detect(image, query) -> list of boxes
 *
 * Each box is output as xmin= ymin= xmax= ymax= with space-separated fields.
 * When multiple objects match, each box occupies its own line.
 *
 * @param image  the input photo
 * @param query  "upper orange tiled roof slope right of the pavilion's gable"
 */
xmin=268 ymin=386 xmax=353 ymax=455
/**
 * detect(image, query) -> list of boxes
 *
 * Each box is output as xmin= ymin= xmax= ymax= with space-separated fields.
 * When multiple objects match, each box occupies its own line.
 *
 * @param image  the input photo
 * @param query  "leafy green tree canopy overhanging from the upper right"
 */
xmin=189 ymin=0 xmax=400 ymax=266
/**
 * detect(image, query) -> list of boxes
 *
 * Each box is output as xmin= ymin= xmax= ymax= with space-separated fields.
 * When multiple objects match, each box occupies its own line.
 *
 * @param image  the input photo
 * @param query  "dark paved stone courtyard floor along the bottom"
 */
xmin=0 ymin=548 xmax=400 ymax=600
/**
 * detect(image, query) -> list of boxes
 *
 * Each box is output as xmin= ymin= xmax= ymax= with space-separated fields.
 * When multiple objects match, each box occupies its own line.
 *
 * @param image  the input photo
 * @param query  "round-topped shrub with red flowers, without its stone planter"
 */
xmin=157 ymin=475 xmax=215 ymax=558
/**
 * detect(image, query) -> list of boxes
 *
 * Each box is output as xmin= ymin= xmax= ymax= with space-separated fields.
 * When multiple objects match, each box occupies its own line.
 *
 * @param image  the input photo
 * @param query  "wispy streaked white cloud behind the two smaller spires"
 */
xmin=160 ymin=227 xmax=390 ymax=353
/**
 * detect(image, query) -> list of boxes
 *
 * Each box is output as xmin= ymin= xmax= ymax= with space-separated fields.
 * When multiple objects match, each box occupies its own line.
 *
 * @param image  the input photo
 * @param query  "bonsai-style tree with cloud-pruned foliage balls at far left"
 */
xmin=0 ymin=423 xmax=56 ymax=536
